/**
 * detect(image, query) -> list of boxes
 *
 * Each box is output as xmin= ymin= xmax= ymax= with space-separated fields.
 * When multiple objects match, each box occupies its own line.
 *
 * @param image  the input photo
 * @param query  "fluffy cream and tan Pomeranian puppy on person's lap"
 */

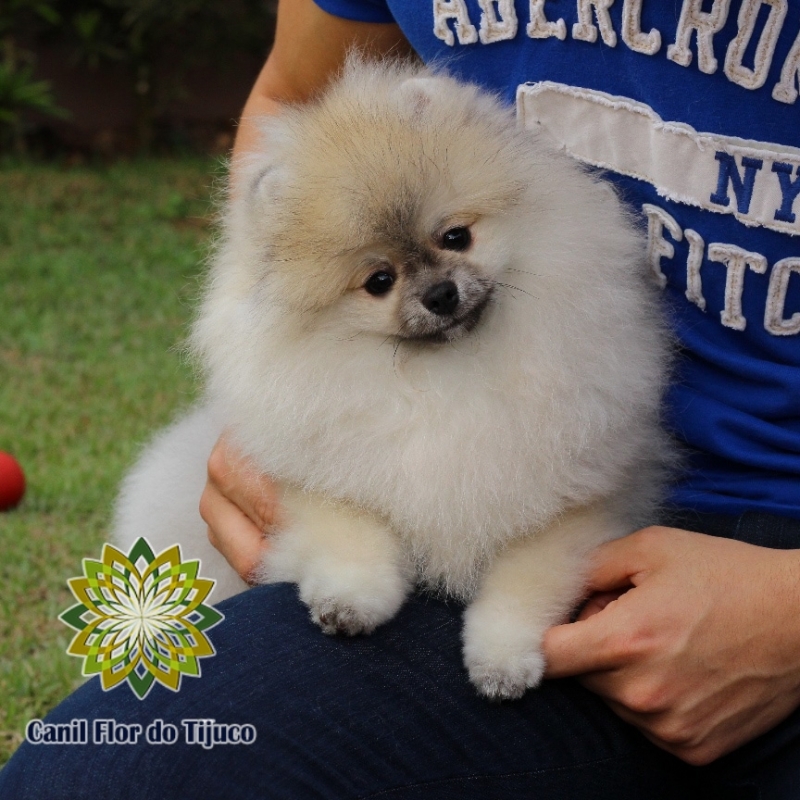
xmin=116 ymin=58 xmax=670 ymax=699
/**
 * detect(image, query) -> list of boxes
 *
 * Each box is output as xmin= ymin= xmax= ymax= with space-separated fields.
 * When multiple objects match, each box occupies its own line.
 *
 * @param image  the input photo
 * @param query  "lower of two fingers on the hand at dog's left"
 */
xmin=200 ymin=482 xmax=268 ymax=583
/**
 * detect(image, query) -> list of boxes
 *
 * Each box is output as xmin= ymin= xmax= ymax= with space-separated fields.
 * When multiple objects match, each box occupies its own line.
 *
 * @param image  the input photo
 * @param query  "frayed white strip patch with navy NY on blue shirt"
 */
xmin=517 ymin=81 xmax=800 ymax=236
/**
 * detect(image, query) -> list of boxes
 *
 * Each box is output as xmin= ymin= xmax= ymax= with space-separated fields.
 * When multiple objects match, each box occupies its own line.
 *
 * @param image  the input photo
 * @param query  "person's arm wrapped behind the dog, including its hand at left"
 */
xmin=200 ymin=0 xmax=411 ymax=580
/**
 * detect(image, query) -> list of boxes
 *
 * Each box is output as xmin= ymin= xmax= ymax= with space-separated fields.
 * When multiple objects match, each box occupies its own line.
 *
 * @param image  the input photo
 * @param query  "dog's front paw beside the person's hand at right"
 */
xmin=464 ymin=601 xmax=545 ymax=700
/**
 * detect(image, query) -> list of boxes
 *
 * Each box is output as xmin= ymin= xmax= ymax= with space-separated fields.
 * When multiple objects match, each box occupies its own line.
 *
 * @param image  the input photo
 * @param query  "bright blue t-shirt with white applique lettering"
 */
xmin=317 ymin=0 xmax=800 ymax=518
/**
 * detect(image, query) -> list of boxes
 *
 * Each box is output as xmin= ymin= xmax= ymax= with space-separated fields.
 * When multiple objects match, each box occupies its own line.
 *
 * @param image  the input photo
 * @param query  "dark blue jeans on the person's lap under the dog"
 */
xmin=0 ymin=515 xmax=800 ymax=800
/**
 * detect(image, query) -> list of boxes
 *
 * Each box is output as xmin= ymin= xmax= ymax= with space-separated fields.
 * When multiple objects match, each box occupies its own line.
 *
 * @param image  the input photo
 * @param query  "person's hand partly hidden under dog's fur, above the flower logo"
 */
xmin=200 ymin=434 xmax=279 ymax=583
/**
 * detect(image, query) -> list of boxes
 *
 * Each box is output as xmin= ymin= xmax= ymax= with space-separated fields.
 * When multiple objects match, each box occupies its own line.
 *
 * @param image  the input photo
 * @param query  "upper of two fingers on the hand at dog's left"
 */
xmin=206 ymin=434 xmax=279 ymax=533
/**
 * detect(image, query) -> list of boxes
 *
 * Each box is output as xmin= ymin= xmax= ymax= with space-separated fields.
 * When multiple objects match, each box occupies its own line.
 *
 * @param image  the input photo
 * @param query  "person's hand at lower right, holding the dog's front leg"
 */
xmin=544 ymin=528 xmax=800 ymax=765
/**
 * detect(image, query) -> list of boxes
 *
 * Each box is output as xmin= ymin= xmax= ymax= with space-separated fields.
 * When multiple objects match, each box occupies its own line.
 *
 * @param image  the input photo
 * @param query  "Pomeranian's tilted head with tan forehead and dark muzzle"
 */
xmin=232 ymin=59 xmax=544 ymax=342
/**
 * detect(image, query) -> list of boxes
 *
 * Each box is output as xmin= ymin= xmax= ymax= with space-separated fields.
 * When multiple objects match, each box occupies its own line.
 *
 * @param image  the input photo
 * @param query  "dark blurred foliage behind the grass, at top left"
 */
xmin=0 ymin=0 xmax=276 ymax=155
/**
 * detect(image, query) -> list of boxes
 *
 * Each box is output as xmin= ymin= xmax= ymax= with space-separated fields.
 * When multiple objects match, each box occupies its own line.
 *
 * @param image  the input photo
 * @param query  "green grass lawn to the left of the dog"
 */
xmin=0 ymin=155 xmax=219 ymax=764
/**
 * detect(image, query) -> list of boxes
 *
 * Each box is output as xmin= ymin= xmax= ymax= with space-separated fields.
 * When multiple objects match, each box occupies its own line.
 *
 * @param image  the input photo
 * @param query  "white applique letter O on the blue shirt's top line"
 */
xmin=725 ymin=0 xmax=787 ymax=89
